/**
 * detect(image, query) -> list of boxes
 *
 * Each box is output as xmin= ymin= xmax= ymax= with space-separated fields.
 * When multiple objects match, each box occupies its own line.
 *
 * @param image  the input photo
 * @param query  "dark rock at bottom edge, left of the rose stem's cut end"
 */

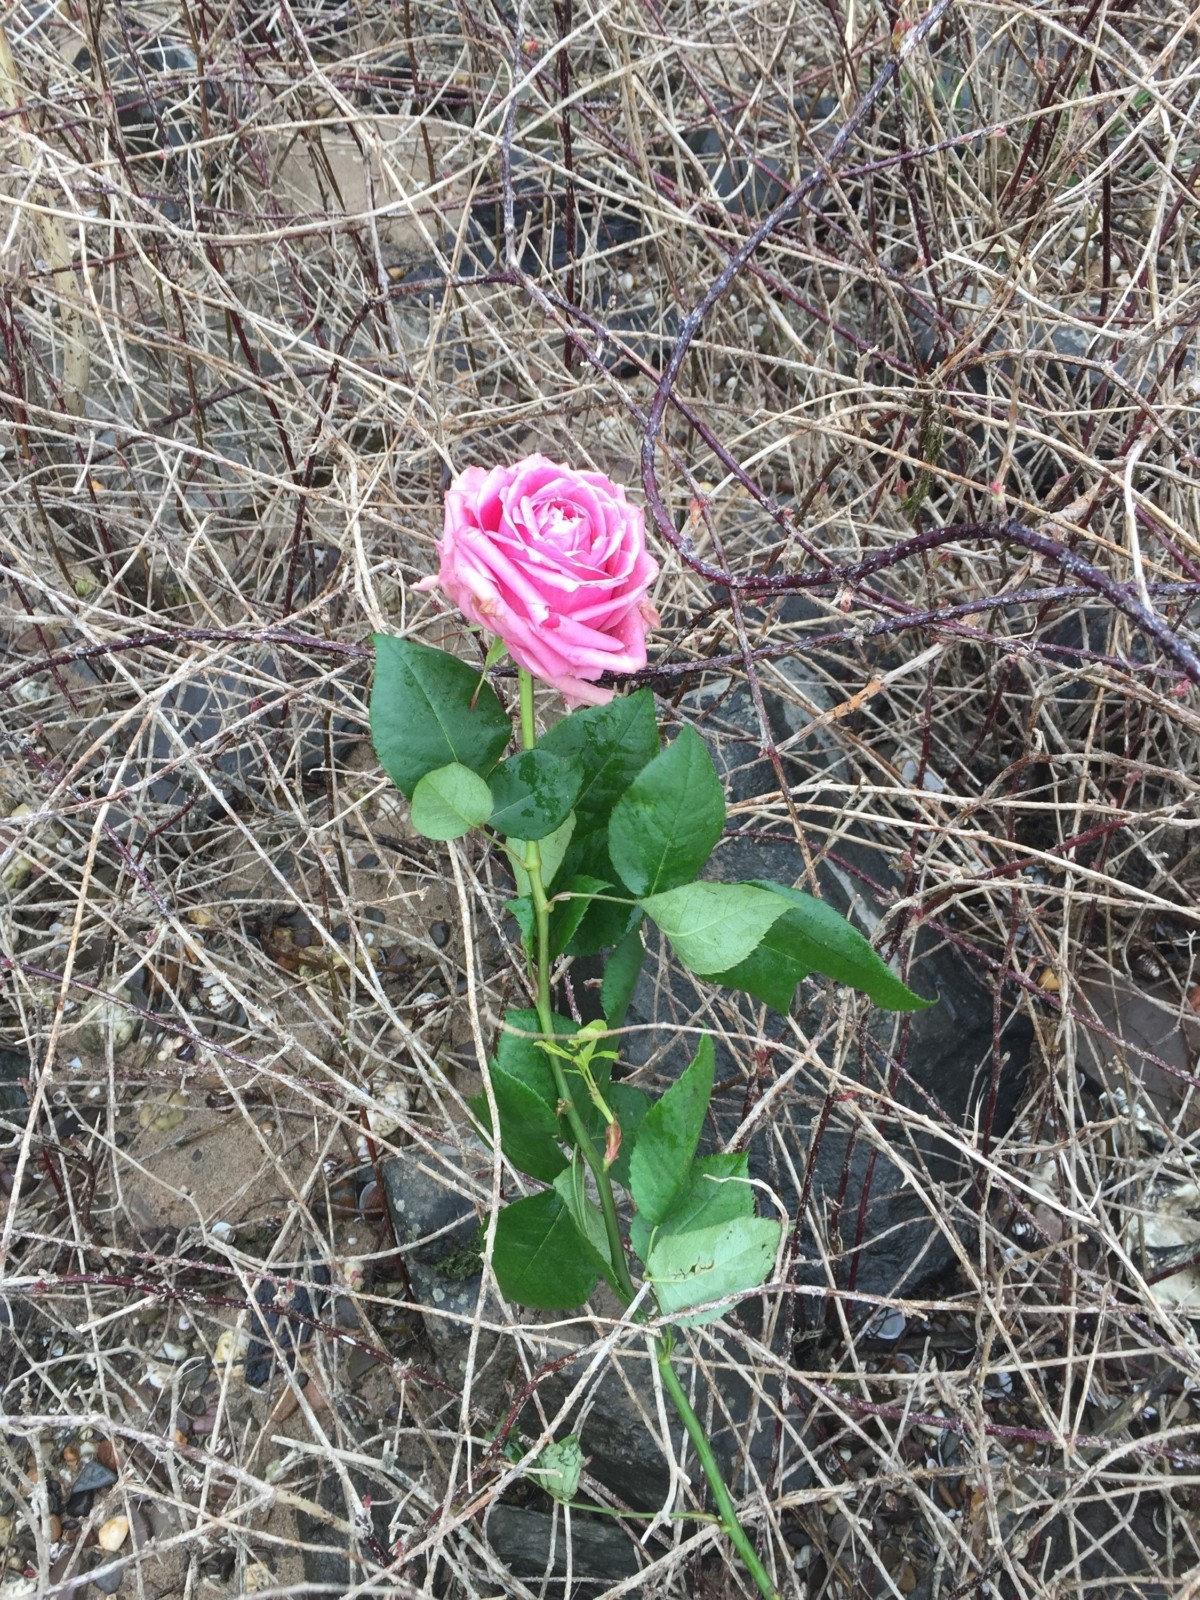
xmin=483 ymin=1506 xmax=645 ymax=1600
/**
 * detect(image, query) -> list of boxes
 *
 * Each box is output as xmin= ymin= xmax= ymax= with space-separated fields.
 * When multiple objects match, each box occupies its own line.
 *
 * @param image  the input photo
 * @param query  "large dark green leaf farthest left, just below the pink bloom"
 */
xmin=371 ymin=634 xmax=512 ymax=800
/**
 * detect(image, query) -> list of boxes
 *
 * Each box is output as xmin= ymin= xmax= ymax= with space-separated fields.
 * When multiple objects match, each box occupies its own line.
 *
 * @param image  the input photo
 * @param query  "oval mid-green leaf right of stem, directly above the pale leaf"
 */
xmin=608 ymin=728 xmax=725 ymax=894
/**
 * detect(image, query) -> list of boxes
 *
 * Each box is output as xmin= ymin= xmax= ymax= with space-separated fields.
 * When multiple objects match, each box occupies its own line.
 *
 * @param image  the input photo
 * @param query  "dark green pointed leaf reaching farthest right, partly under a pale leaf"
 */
xmin=714 ymin=880 xmax=936 ymax=1013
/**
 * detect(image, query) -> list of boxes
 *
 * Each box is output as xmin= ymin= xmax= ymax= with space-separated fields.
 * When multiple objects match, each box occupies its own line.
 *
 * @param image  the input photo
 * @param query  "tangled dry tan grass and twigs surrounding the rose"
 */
xmin=0 ymin=0 xmax=1200 ymax=1600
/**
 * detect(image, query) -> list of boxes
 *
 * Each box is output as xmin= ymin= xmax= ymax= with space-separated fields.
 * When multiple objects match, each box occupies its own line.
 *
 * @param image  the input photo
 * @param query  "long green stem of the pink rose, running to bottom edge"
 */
xmin=517 ymin=667 xmax=779 ymax=1600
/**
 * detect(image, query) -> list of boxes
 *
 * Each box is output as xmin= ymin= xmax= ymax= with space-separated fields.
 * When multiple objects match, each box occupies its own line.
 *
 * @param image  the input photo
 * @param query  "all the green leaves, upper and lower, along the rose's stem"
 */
xmin=371 ymin=638 xmax=928 ymax=1323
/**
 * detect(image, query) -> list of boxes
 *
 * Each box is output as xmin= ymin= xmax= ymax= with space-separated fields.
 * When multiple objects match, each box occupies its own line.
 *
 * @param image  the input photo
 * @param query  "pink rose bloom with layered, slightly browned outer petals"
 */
xmin=418 ymin=456 xmax=658 ymax=706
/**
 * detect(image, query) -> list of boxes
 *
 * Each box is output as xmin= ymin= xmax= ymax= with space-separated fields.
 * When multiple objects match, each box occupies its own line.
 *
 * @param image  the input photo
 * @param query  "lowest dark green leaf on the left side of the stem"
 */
xmin=491 ymin=1189 xmax=603 ymax=1310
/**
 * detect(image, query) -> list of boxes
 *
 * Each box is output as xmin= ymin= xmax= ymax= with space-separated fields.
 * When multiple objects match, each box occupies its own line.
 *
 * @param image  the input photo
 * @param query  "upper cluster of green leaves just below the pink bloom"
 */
xmin=371 ymin=635 xmax=930 ymax=1026
